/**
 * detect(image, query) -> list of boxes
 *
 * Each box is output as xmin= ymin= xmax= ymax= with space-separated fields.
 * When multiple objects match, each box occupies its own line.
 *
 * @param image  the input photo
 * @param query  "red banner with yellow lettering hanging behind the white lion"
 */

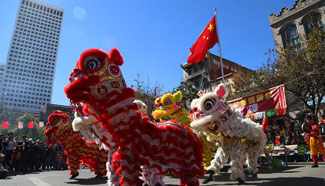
xmin=228 ymin=85 xmax=287 ymax=116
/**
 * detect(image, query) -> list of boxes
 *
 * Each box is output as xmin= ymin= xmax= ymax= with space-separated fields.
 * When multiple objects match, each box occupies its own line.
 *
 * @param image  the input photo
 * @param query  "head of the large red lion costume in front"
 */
xmin=64 ymin=48 xmax=134 ymax=115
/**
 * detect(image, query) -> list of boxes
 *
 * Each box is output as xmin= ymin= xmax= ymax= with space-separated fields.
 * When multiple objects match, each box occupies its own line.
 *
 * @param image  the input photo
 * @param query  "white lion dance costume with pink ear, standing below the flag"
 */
xmin=191 ymin=84 xmax=266 ymax=183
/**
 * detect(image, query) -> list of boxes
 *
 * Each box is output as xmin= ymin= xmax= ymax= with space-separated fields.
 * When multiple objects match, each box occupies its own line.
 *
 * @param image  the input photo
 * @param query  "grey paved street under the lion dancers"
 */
xmin=0 ymin=163 xmax=325 ymax=186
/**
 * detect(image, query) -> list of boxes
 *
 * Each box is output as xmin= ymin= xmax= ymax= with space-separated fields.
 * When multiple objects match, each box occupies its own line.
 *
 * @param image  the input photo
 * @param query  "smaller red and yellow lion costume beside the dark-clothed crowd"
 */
xmin=44 ymin=111 xmax=107 ymax=179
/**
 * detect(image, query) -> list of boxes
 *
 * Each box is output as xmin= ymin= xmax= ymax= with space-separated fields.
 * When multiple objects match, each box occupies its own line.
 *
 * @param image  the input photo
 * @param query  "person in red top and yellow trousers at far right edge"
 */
xmin=306 ymin=115 xmax=325 ymax=168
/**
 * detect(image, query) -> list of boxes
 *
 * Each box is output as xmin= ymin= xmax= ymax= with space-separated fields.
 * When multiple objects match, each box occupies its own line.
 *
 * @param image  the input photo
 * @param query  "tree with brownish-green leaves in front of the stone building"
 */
xmin=232 ymin=26 xmax=325 ymax=117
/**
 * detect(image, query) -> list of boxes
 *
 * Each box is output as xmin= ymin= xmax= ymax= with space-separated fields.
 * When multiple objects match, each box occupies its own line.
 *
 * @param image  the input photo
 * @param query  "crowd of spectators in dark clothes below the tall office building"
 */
xmin=0 ymin=133 xmax=67 ymax=179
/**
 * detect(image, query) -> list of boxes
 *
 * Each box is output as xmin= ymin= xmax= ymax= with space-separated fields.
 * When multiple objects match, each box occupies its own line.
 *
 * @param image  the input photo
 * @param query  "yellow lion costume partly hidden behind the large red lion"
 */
xmin=152 ymin=91 xmax=216 ymax=170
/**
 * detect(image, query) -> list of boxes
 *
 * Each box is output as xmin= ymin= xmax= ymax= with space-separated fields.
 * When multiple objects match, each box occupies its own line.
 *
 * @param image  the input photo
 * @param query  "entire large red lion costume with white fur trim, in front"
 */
xmin=64 ymin=49 xmax=204 ymax=186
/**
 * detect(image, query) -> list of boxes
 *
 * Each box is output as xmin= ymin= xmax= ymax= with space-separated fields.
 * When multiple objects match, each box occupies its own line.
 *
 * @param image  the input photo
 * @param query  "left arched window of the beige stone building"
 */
xmin=281 ymin=24 xmax=300 ymax=49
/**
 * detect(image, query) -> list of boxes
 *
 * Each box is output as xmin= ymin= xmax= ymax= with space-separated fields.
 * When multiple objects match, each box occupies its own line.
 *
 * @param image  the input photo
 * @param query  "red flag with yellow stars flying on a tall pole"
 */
xmin=187 ymin=16 xmax=219 ymax=64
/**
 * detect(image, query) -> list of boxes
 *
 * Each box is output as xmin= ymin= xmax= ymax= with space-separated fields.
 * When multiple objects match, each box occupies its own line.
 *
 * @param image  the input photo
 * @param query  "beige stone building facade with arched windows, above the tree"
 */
xmin=269 ymin=0 xmax=325 ymax=51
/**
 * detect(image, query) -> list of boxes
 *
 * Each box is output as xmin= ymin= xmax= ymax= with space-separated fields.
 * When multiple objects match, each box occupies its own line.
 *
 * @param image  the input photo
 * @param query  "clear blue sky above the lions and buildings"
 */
xmin=0 ymin=0 xmax=295 ymax=105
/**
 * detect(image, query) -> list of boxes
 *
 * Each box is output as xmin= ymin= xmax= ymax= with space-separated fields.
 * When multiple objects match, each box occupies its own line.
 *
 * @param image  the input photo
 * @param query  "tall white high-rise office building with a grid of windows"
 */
xmin=1 ymin=0 xmax=64 ymax=113
